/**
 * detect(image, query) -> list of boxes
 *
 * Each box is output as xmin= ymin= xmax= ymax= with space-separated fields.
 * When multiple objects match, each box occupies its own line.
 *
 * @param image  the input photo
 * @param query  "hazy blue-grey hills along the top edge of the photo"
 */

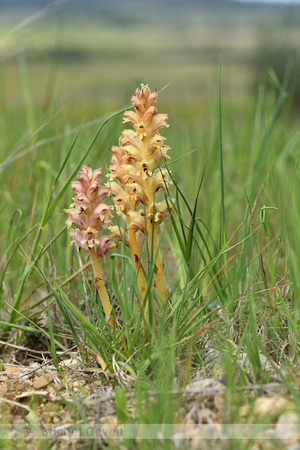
xmin=0 ymin=0 xmax=300 ymax=22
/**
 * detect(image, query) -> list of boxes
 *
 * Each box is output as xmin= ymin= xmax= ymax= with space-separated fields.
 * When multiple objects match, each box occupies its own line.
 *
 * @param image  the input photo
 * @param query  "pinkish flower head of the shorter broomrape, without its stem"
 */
xmin=64 ymin=166 xmax=114 ymax=257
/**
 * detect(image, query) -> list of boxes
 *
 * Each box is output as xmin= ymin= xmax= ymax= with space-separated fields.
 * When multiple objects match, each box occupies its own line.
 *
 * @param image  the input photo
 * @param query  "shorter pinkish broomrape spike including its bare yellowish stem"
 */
xmin=64 ymin=166 xmax=115 ymax=329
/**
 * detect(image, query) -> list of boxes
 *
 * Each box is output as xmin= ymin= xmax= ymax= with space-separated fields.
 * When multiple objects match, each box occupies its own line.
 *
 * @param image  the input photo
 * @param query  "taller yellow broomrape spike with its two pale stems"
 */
xmin=108 ymin=84 xmax=170 ymax=312
